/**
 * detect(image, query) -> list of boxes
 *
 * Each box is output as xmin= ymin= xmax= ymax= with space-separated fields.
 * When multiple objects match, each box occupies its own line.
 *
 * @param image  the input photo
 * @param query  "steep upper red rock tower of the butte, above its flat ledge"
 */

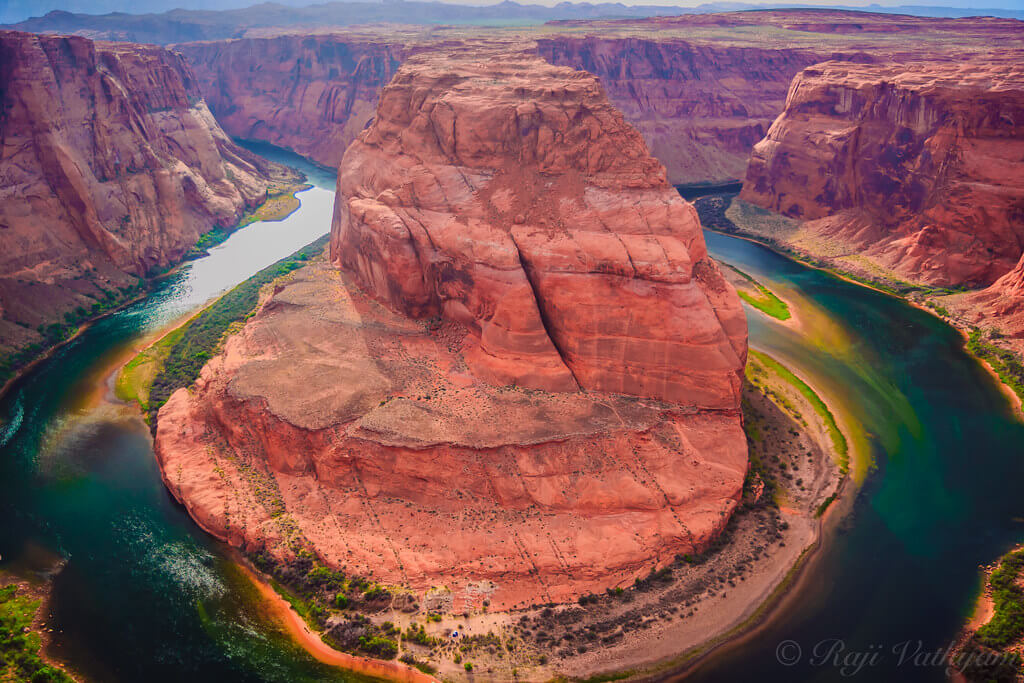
xmin=331 ymin=50 xmax=746 ymax=408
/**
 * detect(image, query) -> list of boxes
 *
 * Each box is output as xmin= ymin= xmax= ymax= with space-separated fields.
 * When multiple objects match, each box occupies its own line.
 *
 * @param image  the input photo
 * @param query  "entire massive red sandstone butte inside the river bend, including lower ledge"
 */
xmin=156 ymin=49 xmax=746 ymax=609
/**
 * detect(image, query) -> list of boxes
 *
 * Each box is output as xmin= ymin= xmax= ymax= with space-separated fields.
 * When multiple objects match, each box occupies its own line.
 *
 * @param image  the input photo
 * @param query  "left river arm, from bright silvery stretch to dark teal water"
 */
xmin=0 ymin=146 xmax=368 ymax=682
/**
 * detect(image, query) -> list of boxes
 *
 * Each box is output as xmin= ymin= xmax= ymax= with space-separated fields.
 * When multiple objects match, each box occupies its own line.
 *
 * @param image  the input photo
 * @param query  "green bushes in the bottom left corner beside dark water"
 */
xmin=0 ymin=585 xmax=72 ymax=683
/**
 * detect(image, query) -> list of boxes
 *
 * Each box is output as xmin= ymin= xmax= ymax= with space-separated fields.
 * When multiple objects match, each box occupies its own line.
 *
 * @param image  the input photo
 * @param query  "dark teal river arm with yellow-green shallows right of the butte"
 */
xmin=693 ymin=233 xmax=1024 ymax=682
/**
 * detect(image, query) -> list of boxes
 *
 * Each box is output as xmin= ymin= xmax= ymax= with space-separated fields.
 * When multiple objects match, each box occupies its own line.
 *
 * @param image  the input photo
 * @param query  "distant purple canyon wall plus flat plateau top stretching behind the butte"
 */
xmin=176 ymin=9 xmax=1024 ymax=189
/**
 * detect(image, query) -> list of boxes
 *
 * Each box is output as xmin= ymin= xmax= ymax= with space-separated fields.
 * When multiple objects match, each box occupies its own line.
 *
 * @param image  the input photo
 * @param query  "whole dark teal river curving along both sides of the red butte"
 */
xmin=0 ymin=162 xmax=1024 ymax=683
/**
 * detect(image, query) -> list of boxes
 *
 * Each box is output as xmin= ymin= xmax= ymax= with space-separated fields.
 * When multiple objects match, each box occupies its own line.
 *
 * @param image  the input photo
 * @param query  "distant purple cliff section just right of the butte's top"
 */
xmin=538 ymin=36 xmax=824 ymax=183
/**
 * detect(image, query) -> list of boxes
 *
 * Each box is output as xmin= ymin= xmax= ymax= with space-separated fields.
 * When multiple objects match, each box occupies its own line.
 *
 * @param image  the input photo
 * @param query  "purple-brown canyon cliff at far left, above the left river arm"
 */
xmin=0 ymin=32 xmax=294 ymax=366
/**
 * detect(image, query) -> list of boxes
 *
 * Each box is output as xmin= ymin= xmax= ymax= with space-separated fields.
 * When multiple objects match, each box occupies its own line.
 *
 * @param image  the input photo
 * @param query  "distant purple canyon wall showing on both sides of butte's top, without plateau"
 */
xmin=175 ymin=33 xmax=823 ymax=183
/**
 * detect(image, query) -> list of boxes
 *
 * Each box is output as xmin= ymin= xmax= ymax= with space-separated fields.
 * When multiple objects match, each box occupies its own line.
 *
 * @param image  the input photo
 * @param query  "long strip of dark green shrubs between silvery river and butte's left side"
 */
xmin=148 ymin=236 xmax=329 ymax=419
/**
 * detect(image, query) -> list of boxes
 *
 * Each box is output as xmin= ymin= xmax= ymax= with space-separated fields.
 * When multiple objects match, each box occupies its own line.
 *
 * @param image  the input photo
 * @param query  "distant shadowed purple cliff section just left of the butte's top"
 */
xmin=175 ymin=35 xmax=406 ymax=168
